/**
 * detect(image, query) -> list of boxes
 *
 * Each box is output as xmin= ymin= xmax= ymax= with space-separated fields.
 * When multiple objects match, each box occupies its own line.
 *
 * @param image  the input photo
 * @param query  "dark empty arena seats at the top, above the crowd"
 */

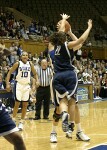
xmin=0 ymin=0 xmax=107 ymax=47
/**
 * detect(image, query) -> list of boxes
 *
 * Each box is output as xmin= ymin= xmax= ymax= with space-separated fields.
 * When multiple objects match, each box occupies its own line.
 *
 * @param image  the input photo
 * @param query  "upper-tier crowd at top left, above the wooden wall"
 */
xmin=0 ymin=11 xmax=56 ymax=40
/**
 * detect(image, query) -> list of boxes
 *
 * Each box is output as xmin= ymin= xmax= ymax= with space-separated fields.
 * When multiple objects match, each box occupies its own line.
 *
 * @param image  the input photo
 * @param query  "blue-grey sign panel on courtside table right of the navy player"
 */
xmin=77 ymin=87 xmax=89 ymax=101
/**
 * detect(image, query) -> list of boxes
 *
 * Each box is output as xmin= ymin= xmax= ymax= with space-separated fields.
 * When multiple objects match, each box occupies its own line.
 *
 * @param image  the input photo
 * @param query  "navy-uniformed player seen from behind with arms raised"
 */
xmin=50 ymin=14 xmax=92 ymax=142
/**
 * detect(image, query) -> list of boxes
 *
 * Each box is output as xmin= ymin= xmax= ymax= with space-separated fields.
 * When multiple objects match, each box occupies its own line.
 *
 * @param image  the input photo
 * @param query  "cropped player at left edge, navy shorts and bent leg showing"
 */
xmin=0 ymin=50 xmax=26 ymax=150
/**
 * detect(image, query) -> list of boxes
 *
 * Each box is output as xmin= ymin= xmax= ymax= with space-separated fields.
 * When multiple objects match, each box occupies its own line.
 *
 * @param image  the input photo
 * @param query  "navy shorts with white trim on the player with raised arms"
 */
xmin=53 ymin=70 xmax=78 ymax=103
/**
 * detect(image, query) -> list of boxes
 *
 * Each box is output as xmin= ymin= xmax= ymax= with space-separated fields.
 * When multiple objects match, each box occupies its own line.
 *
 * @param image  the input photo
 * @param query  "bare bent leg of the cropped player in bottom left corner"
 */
xmin=4 ymin=132 xmax=26 ymax=150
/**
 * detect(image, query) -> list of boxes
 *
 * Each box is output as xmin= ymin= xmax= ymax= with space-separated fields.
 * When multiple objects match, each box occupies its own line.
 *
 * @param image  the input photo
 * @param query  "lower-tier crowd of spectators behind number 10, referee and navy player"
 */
xmin=0 ymin=40 xmax=107 ymax=96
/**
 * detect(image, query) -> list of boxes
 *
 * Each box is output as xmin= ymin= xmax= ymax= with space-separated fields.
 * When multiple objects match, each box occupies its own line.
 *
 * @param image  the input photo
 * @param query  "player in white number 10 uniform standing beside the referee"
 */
xmin=6 ymin=52 xmax=38 ymax=130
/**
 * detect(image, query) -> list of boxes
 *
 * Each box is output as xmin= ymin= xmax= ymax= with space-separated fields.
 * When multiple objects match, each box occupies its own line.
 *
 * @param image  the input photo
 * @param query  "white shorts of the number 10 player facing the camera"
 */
xmin=16 ymin=82 xmax=30 ymax=101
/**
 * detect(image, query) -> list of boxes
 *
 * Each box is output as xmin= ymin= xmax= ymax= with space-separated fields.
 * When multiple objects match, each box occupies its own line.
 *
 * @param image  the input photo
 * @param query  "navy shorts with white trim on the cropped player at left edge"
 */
xmin=0 ymin=104 xmax=19 ymax=136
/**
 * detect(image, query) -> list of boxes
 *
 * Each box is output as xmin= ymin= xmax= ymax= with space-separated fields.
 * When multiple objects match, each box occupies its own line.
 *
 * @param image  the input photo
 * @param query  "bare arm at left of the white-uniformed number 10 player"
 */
xmin=6 ymin=62 xmax=19 ymax=92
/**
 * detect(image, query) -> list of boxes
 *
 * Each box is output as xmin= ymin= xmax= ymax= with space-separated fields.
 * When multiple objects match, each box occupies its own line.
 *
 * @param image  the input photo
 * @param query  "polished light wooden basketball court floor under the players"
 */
xmin=0 ymin=101 xmax=107 ymax=150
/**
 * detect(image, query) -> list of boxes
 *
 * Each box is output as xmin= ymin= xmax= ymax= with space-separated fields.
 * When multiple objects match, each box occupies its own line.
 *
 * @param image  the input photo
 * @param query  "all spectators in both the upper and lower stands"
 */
xmin=0 ymin=11 xmax=107 ymax=112
